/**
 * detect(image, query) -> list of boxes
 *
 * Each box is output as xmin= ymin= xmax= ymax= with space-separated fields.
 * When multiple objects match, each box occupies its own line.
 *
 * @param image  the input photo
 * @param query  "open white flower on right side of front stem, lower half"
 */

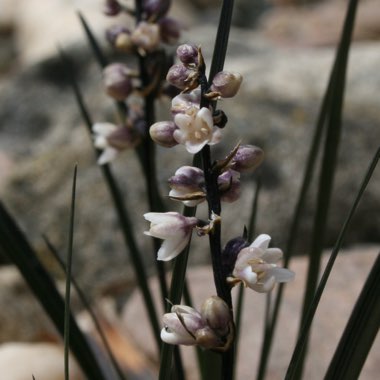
xmin=227 ymin=234 xmax=294 ymax=293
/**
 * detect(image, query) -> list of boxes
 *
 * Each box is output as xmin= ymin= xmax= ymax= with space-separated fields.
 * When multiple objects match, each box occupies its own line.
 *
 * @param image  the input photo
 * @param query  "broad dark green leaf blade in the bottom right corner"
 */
xmin=325 ymin=254 xmax=380 ymax=380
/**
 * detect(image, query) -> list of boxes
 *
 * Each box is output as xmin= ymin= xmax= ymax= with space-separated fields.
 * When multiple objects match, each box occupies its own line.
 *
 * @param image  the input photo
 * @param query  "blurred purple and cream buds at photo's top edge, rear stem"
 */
xmin=104 ymin=0 xmax=180 ymax=56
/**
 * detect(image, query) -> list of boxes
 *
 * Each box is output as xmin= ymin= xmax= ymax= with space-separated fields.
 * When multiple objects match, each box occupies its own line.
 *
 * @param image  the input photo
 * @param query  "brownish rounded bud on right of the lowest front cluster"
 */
xmin=201 ymin=296 xmax=232 ymax=336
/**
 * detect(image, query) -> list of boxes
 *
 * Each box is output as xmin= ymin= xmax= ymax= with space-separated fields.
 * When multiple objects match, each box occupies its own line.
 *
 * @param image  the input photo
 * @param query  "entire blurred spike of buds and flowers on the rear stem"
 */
xmin=92 ymin=0 xmax=180 ymax=165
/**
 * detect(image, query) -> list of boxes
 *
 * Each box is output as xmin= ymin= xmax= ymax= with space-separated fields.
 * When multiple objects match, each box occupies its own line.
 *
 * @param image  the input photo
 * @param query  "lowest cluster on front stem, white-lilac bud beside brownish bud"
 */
xmin=161 ymin=296 xmax=234 ymax=352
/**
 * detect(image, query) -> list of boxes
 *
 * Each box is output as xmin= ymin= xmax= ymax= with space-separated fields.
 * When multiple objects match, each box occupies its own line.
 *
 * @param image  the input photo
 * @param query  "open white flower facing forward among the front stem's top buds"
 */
xmin=173 ymin=106 xmax=221 ymax=154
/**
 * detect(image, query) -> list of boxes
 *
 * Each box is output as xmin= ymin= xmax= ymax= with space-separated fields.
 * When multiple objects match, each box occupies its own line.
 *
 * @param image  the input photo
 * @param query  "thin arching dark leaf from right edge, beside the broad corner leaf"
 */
xmin=286 ymin=148 xmax=380 ymax=380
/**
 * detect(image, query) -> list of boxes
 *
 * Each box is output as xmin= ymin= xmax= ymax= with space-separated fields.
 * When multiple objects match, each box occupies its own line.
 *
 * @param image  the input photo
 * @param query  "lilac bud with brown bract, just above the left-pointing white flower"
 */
xmin=168 ymin=166 xmax=206 ymax=207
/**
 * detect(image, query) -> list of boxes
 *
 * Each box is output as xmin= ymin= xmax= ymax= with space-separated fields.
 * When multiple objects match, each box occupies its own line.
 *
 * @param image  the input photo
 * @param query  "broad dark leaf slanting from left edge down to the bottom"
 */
xmin=0 ymin=202 xmax=106 ymax=380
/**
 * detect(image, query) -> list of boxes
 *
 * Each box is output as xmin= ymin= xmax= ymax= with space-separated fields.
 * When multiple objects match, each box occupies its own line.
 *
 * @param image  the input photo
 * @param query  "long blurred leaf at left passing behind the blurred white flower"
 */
xmin=61 ymin=52 xmax=161 ymax=348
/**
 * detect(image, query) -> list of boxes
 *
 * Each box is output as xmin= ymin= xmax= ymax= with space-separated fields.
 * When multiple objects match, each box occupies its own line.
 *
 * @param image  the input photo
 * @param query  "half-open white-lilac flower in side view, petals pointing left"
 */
xmin=144 ymin=212 xmax=198 ymax=261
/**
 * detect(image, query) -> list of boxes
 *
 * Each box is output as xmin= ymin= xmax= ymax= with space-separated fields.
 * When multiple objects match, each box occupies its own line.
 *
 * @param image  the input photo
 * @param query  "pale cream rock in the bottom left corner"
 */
xmin=0 ymin=343 xmax=84 ymax=380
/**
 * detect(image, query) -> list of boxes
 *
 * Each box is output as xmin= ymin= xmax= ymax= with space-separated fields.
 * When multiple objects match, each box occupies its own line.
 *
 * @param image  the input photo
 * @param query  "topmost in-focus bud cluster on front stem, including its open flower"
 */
xmin=149 ymin=44 xmax=242 ymax=154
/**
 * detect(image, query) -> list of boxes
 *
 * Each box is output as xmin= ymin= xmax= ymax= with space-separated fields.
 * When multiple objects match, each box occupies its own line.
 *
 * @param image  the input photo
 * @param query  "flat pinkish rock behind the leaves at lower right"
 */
xmin=122 ymin=246 xmax=380 ymax=380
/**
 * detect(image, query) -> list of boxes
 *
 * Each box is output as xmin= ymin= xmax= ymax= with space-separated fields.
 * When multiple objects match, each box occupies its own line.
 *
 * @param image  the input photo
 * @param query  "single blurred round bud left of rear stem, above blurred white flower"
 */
xmin=103 ymin=63 xmax=133 ymax=100
